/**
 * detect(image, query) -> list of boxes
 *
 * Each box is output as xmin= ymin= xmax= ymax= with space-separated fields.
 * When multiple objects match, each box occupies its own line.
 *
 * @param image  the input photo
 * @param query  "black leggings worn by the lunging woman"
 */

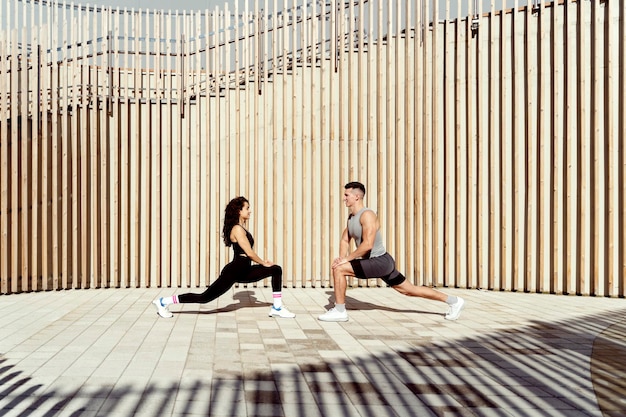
xmin=178 ymin=256 xmax=283 ymax=304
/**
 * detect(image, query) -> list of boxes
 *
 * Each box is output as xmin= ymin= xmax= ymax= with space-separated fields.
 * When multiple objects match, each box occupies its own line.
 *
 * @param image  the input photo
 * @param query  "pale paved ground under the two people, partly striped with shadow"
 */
xmin=0 ymin=288 xmax=626 ymax=417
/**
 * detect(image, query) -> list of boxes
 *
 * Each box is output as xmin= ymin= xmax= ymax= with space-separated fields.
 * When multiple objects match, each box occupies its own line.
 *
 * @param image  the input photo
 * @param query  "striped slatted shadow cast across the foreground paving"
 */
xmin=0 ymin=296 xmax=626 ymax=417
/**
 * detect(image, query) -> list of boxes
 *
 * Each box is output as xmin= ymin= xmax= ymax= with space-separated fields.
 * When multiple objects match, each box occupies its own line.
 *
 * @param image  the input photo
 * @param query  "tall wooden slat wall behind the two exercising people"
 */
xmin=0 ymin=0 xmax=626 ymax=297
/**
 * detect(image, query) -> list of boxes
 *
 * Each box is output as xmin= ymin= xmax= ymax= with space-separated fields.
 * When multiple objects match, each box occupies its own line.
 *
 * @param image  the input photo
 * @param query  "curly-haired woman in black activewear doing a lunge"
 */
xmin=152 ymin=197 xmax=296 ymax=318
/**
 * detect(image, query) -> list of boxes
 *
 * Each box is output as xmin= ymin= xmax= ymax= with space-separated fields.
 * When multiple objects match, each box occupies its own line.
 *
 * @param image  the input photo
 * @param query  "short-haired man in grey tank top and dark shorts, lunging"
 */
xmin=319 ymin=182 xmax=465 ymax=321
